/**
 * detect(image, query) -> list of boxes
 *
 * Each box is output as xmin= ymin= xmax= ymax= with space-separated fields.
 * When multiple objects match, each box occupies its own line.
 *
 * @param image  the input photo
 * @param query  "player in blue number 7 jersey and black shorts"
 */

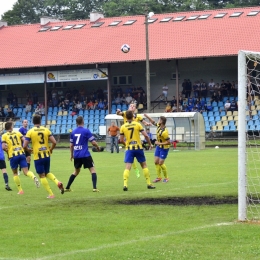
xmin=65 ymin=116 xmax=100 ymax=192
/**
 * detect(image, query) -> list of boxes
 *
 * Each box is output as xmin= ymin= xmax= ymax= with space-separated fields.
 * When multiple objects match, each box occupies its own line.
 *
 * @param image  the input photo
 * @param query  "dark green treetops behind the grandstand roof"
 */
xmin=2 ymin=0 xmax=260 ymax=25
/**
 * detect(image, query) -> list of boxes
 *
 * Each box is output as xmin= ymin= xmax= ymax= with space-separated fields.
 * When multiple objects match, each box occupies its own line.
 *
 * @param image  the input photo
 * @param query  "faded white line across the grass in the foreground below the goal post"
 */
xmin=33 ymin=222 xmax=236 ymax=260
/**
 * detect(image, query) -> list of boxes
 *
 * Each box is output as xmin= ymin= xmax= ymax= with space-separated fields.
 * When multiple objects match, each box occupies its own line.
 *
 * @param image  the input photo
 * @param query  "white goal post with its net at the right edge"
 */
xmin=238 ymin=51 xmax=260 ymax=221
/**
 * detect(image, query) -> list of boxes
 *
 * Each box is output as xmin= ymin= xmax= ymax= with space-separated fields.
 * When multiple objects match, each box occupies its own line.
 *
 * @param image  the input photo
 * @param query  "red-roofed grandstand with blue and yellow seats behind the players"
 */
xmin=0 ymin=7 xmax=260 ymax=134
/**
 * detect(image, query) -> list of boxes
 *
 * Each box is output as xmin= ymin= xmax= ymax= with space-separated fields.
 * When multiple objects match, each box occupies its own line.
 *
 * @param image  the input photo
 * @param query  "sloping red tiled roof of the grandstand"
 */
xmin=0 ymin=7 xmax=260 ymax=69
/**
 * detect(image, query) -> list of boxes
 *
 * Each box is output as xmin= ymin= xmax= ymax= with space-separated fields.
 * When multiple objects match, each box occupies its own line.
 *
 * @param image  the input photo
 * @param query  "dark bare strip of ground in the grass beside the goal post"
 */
xmin=116 ymin=196 xmax=238 ymax=206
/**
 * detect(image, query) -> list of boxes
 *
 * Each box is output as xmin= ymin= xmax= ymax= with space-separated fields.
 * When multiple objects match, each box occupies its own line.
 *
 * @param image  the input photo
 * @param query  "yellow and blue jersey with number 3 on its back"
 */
xmin=25 ymin=126 xmax=52 ymax=160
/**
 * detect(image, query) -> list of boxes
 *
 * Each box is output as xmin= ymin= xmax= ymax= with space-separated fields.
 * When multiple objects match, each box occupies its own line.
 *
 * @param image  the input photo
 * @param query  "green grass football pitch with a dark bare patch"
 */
xmin=0 ymin=148 xmax=260 ymax=260
